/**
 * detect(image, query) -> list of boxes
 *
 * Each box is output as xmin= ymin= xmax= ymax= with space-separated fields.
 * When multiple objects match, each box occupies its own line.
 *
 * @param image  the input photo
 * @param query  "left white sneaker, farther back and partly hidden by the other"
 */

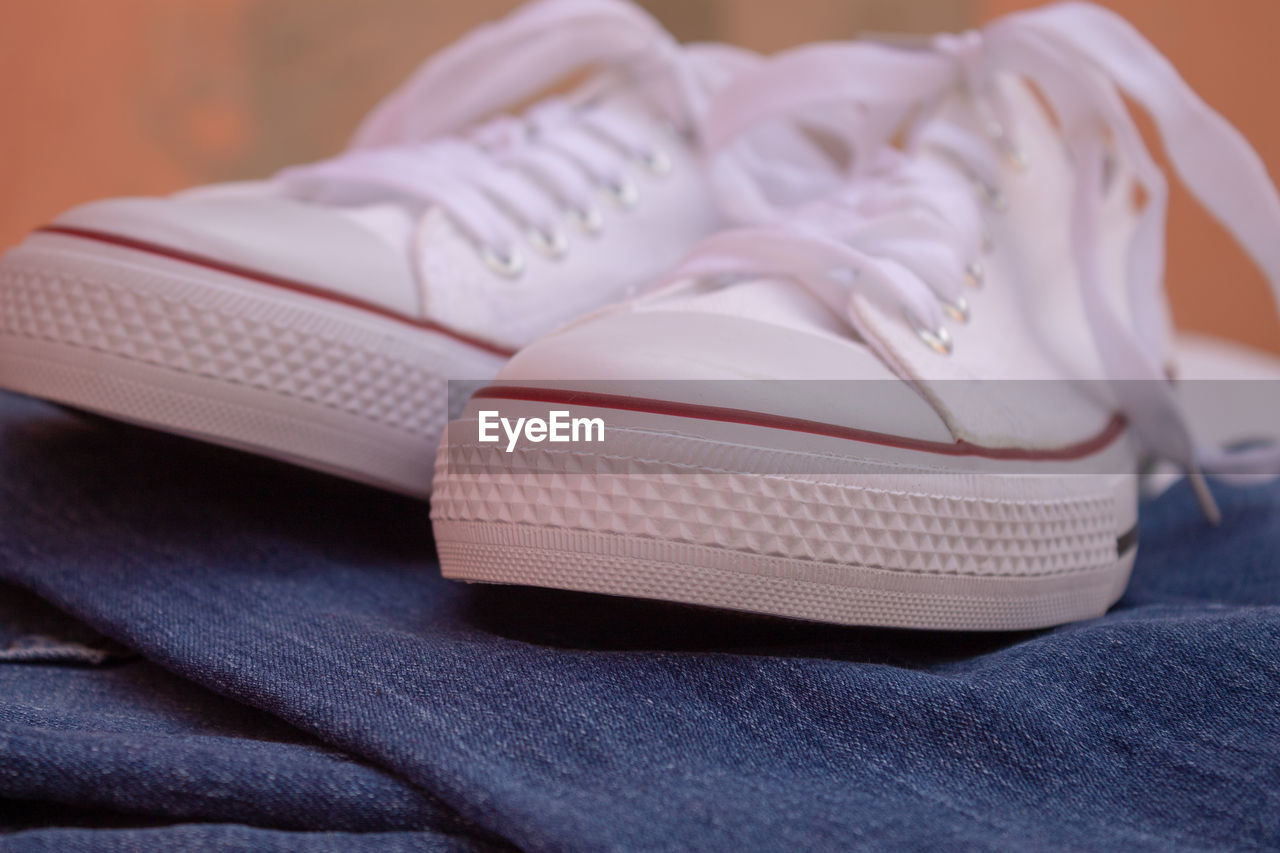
xmin=0 ymin=0 xmax=755 ymax=494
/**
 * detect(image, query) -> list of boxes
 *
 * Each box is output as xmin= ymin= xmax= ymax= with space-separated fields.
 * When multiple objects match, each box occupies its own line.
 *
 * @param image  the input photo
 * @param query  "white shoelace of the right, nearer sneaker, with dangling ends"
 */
xmin=666 ymin=3 xmax=1280 ymax=520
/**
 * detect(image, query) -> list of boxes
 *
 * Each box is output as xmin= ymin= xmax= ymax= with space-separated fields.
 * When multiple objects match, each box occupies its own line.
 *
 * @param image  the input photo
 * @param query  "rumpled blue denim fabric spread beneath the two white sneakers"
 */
xmin=0 ymin=386 xmax=1280 ymax=850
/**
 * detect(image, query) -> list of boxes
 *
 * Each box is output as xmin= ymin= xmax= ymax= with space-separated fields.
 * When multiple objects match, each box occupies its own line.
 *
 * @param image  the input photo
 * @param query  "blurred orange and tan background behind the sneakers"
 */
xmin=0 ymin=0 xmax=1280 ymax=352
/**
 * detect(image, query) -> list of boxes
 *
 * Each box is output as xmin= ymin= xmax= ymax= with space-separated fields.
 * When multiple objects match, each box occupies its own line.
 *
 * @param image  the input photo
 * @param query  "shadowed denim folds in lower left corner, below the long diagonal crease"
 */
xmin=0 ymin=584 xmax=496 ymax=849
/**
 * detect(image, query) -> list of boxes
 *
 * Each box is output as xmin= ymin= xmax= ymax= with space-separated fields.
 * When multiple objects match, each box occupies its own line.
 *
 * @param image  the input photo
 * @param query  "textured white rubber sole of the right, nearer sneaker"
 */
xmin=431 ymin=389 xmax=1137 ymax=630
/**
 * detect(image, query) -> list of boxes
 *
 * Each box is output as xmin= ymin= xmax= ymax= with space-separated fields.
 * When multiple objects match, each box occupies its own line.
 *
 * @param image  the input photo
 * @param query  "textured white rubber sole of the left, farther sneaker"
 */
xmin=0 ymin=234 xmax=504 ymax=497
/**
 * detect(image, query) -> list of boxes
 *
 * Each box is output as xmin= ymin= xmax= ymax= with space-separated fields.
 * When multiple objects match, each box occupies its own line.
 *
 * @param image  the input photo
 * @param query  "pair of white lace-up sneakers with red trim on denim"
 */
xmin=0 ymin=0 xmax=1280 ymax=629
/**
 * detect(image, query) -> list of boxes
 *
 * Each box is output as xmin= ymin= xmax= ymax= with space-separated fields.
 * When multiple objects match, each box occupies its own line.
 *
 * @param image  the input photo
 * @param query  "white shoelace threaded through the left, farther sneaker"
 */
xmin=279 ymin=0 xmax=707 ymax=275
